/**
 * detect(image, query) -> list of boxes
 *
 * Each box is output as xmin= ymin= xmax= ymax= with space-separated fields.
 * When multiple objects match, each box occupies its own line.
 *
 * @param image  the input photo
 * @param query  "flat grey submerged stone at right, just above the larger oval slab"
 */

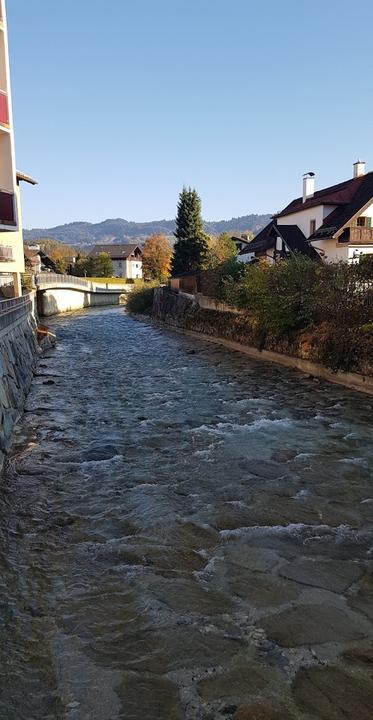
xmin=280 ymin=558 xmax=364 ymax=593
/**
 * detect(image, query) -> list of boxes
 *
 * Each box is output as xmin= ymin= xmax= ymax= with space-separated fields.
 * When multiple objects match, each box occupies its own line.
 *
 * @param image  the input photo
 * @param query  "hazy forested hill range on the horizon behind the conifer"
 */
xmin=24 ymin=214 xmax=271 ymax=247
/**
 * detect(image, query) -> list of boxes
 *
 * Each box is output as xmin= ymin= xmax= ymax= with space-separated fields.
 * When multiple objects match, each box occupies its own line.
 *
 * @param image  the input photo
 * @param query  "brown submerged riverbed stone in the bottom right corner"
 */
xmin=293 ymin=667 xmax=373 ymax=720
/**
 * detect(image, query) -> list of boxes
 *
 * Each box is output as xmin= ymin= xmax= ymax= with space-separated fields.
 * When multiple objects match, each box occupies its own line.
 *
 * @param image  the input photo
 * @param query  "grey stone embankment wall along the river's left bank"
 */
xmin=0 ymin=294 xmax=39 ymax=468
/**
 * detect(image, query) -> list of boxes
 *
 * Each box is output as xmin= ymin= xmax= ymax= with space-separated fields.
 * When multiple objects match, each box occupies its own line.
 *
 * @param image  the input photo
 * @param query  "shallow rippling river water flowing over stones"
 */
xmin=0 ymin=308 xmax=373 ymax=720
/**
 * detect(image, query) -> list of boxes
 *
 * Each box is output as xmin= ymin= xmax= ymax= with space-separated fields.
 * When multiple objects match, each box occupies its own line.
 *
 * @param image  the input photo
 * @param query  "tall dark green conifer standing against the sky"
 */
xmin=172 ymin=187 xmax=208 ymax=275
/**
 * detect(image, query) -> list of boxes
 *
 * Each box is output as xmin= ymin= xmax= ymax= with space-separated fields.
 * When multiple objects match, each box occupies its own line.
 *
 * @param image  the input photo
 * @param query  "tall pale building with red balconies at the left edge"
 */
xmin=0 ymin=0 xmax=36 ymax=297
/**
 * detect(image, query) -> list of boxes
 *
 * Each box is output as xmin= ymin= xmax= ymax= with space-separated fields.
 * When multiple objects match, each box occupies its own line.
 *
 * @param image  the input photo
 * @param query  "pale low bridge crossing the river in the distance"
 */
xmin=35 ymin=273 xmax=132 ymax=317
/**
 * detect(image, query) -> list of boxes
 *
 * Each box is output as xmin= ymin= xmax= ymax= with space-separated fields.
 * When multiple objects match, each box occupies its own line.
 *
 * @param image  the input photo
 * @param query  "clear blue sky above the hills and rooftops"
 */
xmin=7 ymin=0 xmax=373 ymax=227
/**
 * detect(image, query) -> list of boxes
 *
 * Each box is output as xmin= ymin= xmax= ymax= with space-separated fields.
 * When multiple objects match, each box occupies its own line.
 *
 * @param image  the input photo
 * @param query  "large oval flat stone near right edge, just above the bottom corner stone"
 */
xmin=260 ymin=605 xmax=371 ymax=647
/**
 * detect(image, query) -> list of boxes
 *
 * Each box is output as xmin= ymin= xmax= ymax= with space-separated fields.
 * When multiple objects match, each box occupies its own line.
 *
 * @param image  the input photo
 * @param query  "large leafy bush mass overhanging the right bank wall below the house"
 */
xmin=215 ymin=255 xmax=373 ymax=371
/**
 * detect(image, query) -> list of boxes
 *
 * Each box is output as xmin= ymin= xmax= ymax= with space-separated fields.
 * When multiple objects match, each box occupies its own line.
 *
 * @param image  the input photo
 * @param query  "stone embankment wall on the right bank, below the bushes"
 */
xmin=152 ymin=287 xmax=373 ymax=395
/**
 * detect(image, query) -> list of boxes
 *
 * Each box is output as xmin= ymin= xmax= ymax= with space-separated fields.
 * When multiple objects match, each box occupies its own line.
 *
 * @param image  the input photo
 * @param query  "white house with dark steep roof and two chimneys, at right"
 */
xmin=239 ymin=160 xmax=373 ymax=262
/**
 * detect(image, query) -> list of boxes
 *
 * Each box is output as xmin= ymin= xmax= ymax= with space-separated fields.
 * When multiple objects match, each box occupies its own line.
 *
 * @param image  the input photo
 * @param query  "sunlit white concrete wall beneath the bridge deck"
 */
xmin=38 ymin=288 xmax=121 ymax=317
